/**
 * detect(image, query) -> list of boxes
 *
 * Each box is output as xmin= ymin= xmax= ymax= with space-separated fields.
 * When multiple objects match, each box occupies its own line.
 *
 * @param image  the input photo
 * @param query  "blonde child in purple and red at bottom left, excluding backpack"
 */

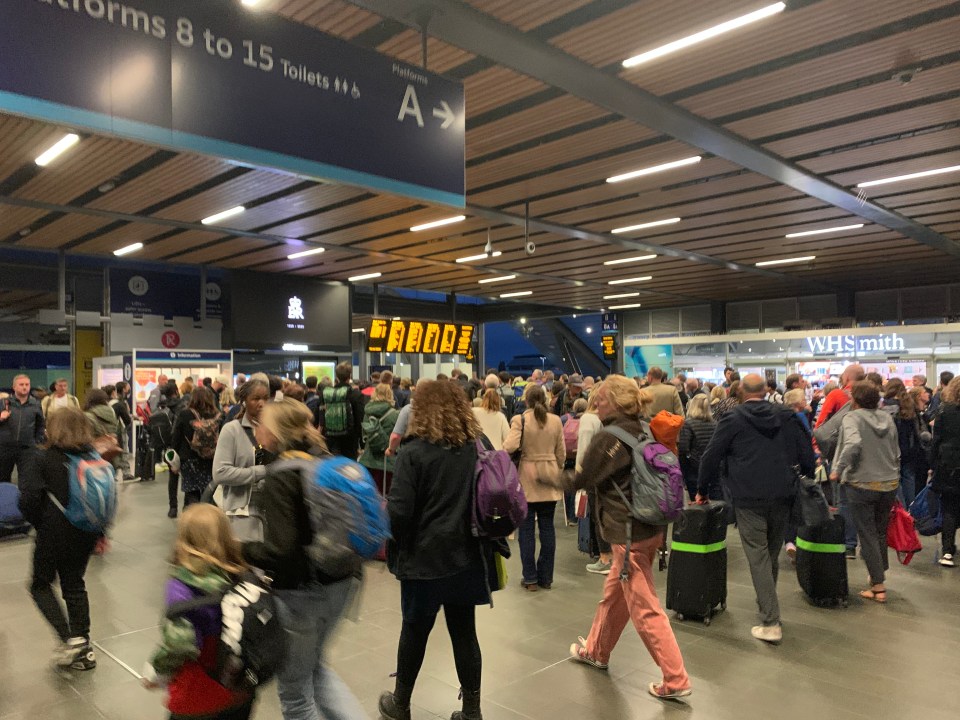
xmin=144 ymin=503 xmax=254 ymax=720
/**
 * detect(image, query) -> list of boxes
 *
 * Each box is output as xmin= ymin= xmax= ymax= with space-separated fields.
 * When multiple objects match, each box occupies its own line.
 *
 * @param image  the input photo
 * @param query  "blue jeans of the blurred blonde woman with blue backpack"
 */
xmin=277 ymin=579 xmax=367 ymax=720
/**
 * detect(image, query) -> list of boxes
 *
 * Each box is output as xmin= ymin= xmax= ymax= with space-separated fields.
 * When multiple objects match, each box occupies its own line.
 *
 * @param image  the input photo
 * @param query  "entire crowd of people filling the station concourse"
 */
xmin=0 ymin=362 xmax=960 ymax=720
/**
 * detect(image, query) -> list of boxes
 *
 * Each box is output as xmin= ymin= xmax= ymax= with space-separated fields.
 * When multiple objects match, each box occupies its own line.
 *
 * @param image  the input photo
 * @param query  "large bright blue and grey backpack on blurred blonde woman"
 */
xmin=271 ymin=456 xmax=391 ymax=579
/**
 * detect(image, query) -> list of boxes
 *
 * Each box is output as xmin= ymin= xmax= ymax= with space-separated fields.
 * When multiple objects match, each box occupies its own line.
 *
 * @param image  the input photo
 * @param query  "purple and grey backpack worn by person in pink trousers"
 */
xmin=603 ymin=423 xmax=686 ymax=579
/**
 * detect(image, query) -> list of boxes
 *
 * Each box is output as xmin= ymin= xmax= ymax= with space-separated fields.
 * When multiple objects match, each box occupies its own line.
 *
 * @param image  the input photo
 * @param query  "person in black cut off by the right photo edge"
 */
xmin=930 ymin=377 xmax=960 ymax=567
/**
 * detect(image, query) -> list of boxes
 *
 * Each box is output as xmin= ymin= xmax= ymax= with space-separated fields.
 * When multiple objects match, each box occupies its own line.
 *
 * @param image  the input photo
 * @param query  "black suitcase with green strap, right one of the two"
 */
xmin=797 ymin=514 xmax=849 ymax=607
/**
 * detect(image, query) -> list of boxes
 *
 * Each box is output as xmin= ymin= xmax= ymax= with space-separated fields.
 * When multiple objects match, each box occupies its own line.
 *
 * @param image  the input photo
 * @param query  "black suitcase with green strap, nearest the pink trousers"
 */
xmin=667 ymin=502 xmax=727 ymax=625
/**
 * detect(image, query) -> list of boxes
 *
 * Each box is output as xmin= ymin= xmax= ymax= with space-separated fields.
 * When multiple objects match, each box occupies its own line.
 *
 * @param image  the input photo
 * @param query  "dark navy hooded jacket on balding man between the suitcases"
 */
xmin=698 ymin=398 xmax=816 ymax=508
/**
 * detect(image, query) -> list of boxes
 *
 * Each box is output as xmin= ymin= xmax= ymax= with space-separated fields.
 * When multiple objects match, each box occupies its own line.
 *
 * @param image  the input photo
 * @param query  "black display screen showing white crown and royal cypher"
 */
xmin=223 ymin=271 xmax=350 ymax=350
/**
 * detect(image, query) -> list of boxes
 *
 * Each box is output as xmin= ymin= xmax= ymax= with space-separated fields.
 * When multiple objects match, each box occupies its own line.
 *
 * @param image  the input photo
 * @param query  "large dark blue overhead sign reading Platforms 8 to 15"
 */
xmin=0 ymin=0 xmax=465 ymax=207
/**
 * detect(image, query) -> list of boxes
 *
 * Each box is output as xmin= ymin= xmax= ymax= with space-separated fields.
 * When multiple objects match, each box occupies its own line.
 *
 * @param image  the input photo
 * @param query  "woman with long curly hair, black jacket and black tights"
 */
xmin=380 ymin=381 xmax=490 ymax=720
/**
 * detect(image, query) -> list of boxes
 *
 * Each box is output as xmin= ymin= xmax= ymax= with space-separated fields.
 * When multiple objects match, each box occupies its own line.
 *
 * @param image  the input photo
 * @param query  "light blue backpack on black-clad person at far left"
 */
xmin=47 ymin=452 xmax=117 ymax=535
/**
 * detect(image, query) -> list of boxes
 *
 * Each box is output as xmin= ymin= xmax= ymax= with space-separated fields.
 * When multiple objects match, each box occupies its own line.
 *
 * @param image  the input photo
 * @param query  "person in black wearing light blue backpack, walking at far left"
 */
xmin=20 ymin=408 xmax=116 ymax=670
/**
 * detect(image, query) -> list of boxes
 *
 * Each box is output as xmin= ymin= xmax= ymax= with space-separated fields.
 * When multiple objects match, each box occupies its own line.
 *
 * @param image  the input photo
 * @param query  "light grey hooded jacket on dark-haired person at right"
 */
xmin=833 ymin=408 xmax=900 ymax=491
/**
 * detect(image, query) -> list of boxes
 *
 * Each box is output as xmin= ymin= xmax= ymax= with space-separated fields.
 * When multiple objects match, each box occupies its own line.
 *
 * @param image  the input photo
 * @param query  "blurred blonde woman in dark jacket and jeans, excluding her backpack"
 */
xmin=240 ymin=400 xmax=366 ymax=720
